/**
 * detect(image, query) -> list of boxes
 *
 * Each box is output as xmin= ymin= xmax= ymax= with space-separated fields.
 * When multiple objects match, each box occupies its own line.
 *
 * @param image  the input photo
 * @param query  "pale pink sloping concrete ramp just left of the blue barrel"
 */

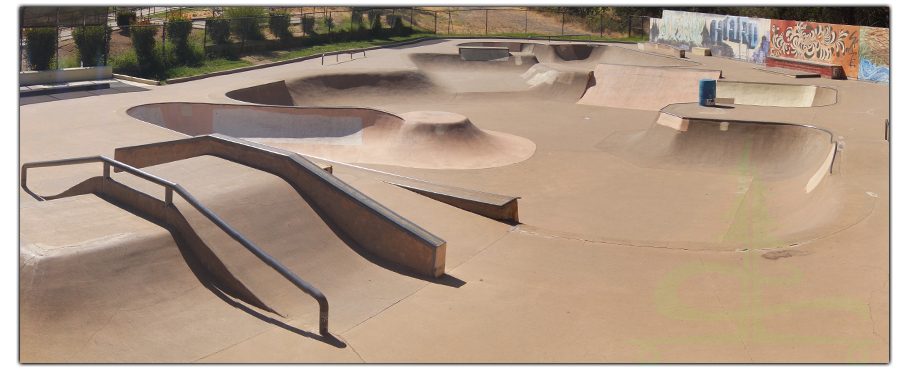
xmin=578 ymin=64 xmax=722 ymax=111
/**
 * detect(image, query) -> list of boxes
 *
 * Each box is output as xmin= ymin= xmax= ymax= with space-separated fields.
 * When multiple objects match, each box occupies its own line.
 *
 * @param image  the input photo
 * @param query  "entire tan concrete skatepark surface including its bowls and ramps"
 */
xmin=18 ymin=39 xmax=890 ymax=363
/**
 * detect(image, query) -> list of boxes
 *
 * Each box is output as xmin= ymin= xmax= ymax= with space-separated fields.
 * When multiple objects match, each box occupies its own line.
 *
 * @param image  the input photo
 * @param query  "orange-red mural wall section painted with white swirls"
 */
xmin=769 ymin=20 xmax=859 ymax=78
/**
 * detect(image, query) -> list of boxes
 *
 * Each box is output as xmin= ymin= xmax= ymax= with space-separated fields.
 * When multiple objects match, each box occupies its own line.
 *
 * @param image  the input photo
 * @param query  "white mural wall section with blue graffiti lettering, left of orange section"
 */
xmin=650 ymin=10 xmax=769 ymax=63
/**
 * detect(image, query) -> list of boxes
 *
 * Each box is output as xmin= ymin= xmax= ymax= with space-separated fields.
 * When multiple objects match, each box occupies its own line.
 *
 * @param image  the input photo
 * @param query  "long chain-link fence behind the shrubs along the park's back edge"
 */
xmin=20 ymin=7 xmax=650 ymax=76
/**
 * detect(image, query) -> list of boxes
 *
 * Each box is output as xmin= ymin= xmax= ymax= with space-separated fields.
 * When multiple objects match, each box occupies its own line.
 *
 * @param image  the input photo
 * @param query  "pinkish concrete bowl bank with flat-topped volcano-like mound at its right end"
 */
xmin=128 ymin=103 xmax=535 ymax=169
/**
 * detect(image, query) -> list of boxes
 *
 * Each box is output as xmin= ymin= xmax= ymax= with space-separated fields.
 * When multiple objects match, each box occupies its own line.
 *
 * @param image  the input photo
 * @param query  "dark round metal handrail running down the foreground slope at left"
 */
xmin=22 ymin=156 xmax=328 ymax=336
